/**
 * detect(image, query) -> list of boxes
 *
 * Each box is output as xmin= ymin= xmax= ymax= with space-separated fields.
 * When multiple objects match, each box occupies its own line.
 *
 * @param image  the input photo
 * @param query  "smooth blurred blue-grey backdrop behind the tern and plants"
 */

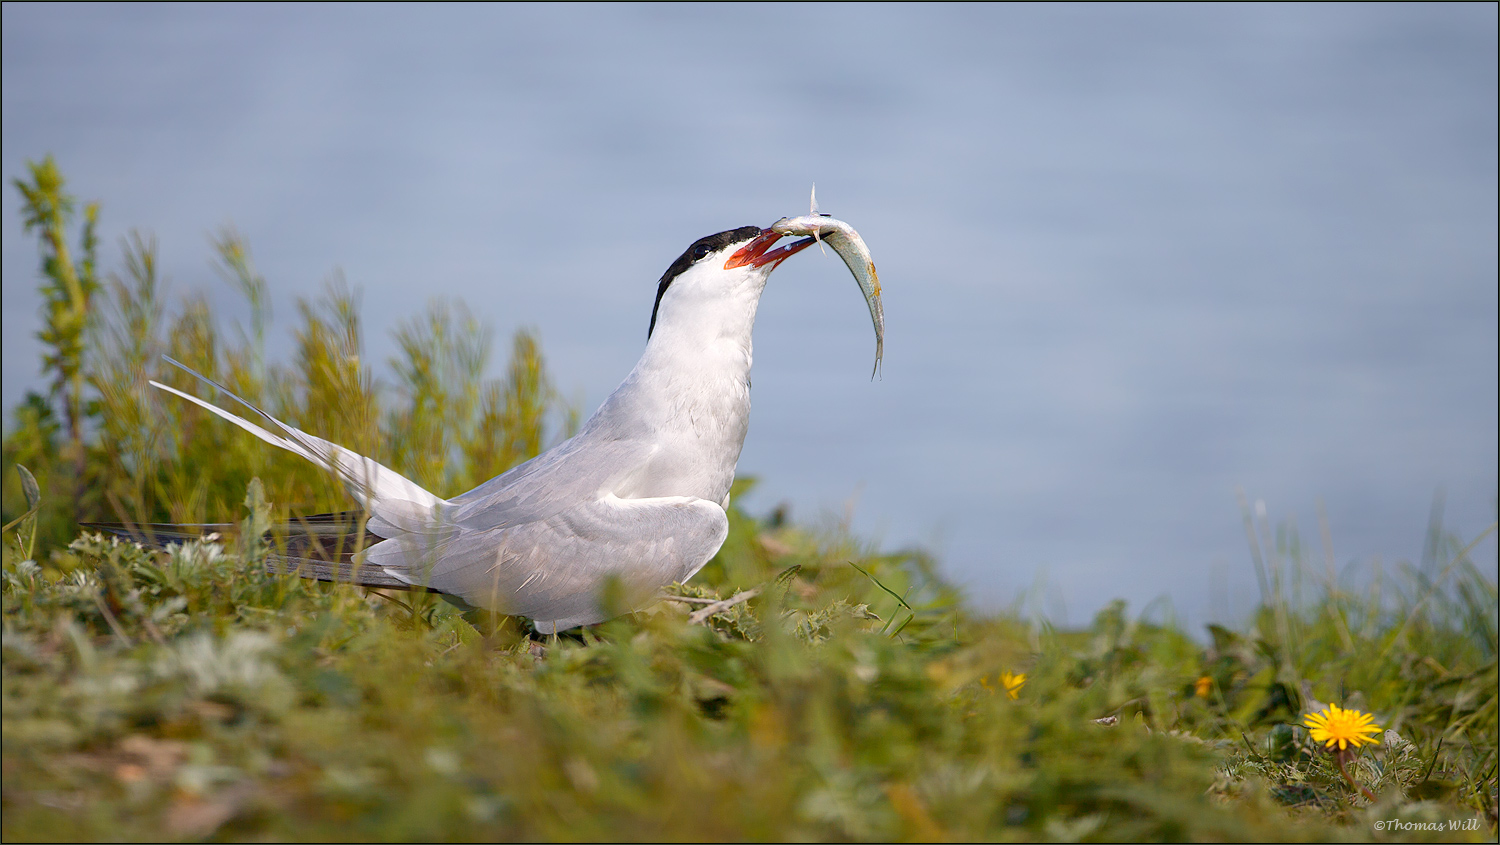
xmin=0 ymin=3 xmax=1500 ymax=624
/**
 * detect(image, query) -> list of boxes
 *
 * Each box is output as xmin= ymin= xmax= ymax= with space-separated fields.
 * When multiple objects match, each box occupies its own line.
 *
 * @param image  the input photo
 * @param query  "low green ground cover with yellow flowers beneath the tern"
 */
xmin=3 ymin=486 xmax=1496 ymax=840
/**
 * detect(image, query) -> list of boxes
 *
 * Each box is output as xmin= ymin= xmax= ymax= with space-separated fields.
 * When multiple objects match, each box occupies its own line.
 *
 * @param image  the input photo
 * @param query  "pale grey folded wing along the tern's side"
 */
xmin=369 ymin=495 xmax=729 ymax=632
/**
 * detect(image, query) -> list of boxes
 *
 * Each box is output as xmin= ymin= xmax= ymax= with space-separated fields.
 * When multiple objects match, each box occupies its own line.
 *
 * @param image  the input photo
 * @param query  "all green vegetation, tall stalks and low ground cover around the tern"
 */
xmin=3 ymin=160 xmax=1497 ymax=840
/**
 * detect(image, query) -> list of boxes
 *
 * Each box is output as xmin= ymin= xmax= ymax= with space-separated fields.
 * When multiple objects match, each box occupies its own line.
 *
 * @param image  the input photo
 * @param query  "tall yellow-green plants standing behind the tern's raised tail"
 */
xmin=3 ymin=159 xmax=578 ymax=560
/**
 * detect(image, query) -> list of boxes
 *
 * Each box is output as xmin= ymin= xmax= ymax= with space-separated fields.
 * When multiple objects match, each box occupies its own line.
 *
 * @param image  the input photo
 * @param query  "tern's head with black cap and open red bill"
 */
xmin=647 ymin=227 xmax=813 ymax=338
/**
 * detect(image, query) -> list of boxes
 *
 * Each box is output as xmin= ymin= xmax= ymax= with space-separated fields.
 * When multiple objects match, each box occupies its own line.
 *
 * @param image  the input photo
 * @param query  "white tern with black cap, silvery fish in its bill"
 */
xmin=101 ymin=218 xmax=884 ymax=633
